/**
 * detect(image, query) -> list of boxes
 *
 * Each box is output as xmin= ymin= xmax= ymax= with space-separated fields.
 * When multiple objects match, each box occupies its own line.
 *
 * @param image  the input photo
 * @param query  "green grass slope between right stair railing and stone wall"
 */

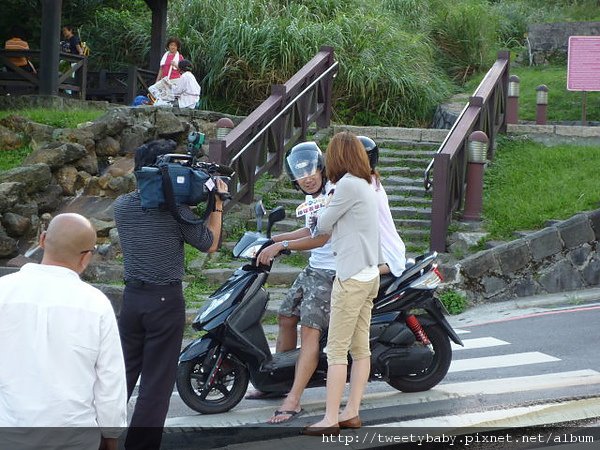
xmin=483 ymin=138 xmax=600 ymax=239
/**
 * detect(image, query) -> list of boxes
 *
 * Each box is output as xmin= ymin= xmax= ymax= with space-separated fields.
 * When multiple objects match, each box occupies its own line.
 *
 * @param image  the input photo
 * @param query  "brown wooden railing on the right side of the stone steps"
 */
xmin=425 ymin=52 xmax=510 ymax=252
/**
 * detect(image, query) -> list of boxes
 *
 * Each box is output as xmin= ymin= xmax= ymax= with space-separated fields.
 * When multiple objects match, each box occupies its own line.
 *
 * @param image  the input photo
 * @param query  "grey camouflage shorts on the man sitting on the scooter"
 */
xmin=279 ymin=266 xmax=335 ymax=331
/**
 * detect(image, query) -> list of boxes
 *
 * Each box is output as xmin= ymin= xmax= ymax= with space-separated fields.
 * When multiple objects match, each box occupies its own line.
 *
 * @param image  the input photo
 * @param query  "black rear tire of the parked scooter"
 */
xmin=388 ymin=325 xmax=452 ymax=392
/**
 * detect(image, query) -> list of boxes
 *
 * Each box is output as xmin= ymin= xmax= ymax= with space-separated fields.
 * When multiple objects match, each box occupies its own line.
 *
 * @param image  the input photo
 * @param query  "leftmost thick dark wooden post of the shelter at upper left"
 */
xmin=39 ymin=0 xmax=62 ymax=95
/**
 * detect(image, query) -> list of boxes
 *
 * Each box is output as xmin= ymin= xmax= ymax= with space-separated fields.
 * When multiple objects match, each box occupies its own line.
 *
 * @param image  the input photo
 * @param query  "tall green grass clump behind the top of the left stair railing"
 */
xmin=171 ymin=0 xmax=451 ymax=126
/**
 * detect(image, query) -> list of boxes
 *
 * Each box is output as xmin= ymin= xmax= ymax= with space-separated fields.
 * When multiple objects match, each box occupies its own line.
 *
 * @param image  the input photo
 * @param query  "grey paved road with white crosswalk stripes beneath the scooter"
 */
xmin=127 ymin=293 xmax=600 ymax=449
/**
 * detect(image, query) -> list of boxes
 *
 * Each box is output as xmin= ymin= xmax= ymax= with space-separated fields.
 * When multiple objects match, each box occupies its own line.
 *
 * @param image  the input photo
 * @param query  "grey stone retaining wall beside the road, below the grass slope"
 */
xmin=446 ymin=209 xmax=600 ymax=302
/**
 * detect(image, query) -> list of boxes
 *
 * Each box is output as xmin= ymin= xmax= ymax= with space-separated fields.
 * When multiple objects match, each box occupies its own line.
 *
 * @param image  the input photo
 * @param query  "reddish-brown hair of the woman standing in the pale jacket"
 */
xmin=325 ymin=131 xmax=371 ymax=183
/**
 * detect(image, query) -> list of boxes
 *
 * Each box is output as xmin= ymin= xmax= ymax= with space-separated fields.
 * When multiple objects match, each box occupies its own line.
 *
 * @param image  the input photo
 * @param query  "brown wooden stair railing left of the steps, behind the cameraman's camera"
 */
xmin=209 ymin=47 xmax=338 ymax=208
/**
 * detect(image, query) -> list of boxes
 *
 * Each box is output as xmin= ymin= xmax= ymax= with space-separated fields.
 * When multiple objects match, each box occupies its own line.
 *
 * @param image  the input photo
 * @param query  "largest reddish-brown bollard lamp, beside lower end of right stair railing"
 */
xmin=462 ymin=131 xmax=489 ymax=221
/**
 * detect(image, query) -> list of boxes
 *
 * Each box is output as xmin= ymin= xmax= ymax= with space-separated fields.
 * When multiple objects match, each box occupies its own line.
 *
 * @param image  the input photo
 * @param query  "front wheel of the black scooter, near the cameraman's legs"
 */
xmin=177 ymin=347 xmax=248 ymax=414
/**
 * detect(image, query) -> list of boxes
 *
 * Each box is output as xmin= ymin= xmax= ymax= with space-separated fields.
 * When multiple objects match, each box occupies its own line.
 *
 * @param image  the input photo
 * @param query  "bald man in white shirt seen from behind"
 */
xmin=0 ymin=214 xmax=127 ymax=450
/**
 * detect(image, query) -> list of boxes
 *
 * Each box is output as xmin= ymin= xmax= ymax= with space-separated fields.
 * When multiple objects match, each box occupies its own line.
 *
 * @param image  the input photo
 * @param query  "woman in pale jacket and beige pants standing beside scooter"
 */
xmin=304 ymin=132 xmax=383 ymax=436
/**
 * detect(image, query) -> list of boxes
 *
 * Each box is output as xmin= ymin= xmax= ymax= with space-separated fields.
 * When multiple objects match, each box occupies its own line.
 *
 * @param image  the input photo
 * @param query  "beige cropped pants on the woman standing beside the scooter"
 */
xmin=327 ymin=276 xmax=379 ymax=366
